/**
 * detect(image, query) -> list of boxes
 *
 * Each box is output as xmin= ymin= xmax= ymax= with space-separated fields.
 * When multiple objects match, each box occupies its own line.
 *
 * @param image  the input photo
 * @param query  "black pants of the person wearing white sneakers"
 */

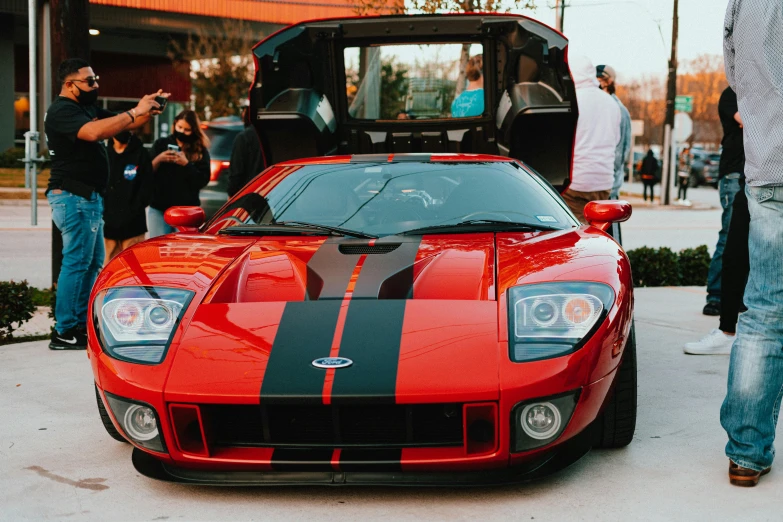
xmin=719 ymin=180 xmax=750 ymax=333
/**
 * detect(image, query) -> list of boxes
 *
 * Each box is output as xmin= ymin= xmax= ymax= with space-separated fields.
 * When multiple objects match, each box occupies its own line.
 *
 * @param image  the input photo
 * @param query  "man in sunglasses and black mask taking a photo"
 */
xmin=44 ymin=58 xmax=168 ymax=350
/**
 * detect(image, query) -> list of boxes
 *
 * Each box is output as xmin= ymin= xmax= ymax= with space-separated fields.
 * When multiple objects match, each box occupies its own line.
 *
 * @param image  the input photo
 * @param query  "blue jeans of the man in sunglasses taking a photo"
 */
xmin=46 ymin=190 xmax=104 ymax=334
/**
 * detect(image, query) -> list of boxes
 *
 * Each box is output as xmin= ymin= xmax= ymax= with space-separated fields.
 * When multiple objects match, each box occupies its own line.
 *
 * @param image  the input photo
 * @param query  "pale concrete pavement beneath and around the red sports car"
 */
xmin=0 ymin=288 xmax=783 ymax=522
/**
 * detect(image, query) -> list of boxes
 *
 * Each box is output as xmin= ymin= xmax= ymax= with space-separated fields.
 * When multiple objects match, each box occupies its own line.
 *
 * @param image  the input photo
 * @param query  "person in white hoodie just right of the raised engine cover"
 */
xmin=562 ymin=55 xmax=620 ymax=223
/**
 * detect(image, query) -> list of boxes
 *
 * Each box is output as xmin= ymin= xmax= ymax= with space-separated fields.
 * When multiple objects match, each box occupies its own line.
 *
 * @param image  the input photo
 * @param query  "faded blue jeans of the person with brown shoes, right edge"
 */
xmin=720 ymin=186 xmax=783 ymax=471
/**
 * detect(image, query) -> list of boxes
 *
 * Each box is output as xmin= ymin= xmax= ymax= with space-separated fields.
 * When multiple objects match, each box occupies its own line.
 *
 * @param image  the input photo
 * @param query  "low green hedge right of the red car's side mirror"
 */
xmin=626 ymin=245 xmax=711 ymax=287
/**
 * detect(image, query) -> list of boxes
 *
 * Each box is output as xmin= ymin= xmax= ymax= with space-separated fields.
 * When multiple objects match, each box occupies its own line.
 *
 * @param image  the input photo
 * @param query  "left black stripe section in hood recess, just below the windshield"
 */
xmin=307 ymin=238 xmax=361 ymax=296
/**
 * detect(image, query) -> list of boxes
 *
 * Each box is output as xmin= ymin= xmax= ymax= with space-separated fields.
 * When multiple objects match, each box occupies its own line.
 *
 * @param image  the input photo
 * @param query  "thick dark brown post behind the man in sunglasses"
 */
xmin=47 ymin=0 xmax=90 ymax=288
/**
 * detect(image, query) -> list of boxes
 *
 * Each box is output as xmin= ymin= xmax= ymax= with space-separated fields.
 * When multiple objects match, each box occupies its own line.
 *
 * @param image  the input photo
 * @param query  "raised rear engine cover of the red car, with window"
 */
xmin=250 ymin=14 xmax=577 ymax=188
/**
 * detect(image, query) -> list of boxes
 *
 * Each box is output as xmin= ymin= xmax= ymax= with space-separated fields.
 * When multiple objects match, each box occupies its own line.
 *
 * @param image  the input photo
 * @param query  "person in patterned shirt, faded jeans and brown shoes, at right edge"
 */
xmin=720 ymin=0 xmax=783 ymax=487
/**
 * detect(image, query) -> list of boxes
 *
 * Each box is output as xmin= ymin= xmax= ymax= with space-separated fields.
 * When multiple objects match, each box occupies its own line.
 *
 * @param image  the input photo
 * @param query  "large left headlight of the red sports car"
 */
xmin=93 ymin=286 xmax=193 ymax=364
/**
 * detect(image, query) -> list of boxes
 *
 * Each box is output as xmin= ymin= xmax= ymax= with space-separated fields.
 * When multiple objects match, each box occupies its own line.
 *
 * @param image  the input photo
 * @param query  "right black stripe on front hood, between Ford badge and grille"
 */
xmin=332 ymin=299 xmax=406 ymax=404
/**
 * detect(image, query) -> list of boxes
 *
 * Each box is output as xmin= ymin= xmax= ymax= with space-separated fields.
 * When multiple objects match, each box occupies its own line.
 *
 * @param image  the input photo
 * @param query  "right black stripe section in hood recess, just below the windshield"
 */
xmin=353 ymin=236 xmax=421 ymax=299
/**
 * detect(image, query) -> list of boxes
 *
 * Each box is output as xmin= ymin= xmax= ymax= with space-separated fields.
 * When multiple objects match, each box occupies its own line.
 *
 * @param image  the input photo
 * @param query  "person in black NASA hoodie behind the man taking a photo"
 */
xmin=103 ymin=131 xmax=152 ymax=260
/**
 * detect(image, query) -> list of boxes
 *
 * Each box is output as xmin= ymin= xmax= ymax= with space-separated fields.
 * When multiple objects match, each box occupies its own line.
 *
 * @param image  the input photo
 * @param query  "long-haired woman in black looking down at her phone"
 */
xmin=147 ymin=110 xmax=209 ymax=237
